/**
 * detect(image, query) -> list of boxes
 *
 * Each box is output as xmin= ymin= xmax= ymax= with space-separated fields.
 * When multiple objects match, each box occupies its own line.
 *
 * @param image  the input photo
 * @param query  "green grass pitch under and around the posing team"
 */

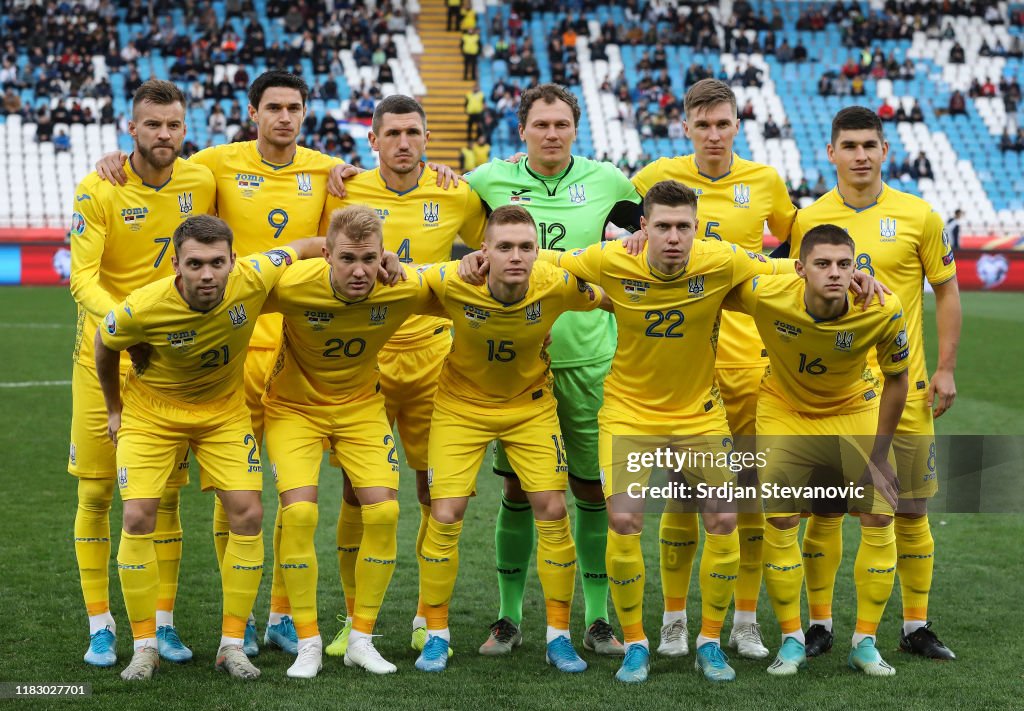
xmin=0 ymin=288 xmax=1024 ymax=710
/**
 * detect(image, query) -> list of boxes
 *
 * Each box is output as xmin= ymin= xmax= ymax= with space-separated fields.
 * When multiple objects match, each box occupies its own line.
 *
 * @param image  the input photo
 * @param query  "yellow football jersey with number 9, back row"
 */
xmin=189 ymin=140 xmax=342 ymax=348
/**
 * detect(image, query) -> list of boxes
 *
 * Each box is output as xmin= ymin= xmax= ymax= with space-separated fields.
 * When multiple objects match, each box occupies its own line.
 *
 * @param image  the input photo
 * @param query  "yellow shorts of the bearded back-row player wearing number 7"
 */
xmin=68 ymin=363 xmax=188 ymax=488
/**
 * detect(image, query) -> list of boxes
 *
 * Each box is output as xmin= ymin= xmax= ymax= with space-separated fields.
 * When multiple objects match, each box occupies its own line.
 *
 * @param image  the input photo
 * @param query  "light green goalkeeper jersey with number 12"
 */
xmin=466 ymin=156 xmax=642 ymax=368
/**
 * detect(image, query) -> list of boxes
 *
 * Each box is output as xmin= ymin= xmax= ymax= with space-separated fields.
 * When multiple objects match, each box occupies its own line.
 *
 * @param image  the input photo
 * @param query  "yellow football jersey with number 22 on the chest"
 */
xmin=541 ymin=240 xmax=793 ymax=424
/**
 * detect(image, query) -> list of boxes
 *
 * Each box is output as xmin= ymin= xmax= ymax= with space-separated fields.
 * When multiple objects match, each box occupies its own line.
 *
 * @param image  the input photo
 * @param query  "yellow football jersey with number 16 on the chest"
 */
xmin=723 ymin=275 xmax=909 ymax=415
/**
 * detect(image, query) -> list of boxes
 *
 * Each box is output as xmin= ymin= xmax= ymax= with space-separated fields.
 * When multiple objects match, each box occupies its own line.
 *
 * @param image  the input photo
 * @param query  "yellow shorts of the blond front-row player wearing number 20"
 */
xmin=264 ymin=393 xmax=398 ymax=494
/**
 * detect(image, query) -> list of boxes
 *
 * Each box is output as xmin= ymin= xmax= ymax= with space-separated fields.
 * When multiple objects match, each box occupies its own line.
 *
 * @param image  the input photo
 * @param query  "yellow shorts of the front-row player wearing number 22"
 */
xmin=598 ymin=405 xmax=736 ymax=499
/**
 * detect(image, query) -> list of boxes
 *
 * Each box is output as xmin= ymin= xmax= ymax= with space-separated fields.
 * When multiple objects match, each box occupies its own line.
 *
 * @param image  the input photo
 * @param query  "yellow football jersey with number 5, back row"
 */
xmin=633 ymin=155 xmax=797 ymax=368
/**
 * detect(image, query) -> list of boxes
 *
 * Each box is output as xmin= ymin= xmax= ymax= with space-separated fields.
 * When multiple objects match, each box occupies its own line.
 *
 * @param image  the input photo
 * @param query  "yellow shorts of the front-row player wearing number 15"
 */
xmin=427 ymin=387 xmax=568 ymax=499
